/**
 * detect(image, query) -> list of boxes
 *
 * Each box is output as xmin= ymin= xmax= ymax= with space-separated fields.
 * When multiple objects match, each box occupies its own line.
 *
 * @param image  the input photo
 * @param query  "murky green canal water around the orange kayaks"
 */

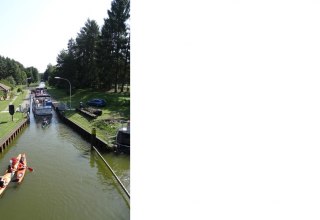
xmin=0 ymin=109 xmax=130 ymax=220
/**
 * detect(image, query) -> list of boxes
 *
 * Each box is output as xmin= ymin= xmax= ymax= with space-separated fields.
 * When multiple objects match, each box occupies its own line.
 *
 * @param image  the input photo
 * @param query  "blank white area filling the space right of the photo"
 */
xmin=131 ymin=0 xmax=320 ymax=220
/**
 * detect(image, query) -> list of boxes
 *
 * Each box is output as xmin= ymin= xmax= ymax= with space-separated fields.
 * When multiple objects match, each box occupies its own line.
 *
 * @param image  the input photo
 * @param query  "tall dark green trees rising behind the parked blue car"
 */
xmin=47 ymin=0 xmax=130 ymax=92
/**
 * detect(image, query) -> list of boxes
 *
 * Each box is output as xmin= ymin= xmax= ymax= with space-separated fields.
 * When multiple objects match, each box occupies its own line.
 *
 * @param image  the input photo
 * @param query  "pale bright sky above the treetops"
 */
xmin=0 ymin=0 xmax=111 ymax=73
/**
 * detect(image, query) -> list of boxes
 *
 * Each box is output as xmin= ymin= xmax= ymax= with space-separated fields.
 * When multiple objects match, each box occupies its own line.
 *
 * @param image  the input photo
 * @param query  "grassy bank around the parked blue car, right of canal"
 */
xmin=48 ymin=88 xmax=130 ymax=144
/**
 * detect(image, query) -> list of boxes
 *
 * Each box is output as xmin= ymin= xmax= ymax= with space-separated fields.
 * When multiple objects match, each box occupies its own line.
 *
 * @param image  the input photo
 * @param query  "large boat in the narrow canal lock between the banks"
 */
xmin=32 ymin=83 xmax=52 ymax=116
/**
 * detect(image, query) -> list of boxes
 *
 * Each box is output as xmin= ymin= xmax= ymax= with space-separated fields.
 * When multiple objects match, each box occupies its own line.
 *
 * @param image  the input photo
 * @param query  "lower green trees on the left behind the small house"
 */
xmin=0 ymin=56 xmax=39 ymax=87
